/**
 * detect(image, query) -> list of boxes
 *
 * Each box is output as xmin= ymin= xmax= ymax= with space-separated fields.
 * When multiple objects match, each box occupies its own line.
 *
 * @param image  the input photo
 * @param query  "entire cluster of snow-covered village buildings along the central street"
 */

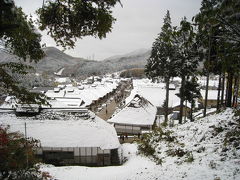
xmin=0 ymin=74 xmax=220 ymax=166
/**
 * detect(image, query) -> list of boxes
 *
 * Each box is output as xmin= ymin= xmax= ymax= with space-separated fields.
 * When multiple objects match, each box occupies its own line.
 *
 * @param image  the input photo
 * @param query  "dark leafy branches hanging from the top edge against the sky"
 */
xmin=37 ymin=0 xmax=120 ymax=48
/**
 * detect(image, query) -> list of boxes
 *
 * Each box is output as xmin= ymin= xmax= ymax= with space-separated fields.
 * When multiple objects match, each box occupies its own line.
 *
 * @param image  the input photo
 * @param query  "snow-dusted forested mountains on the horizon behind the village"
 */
xmin=0 ymin=47 xmax=150 ymax=76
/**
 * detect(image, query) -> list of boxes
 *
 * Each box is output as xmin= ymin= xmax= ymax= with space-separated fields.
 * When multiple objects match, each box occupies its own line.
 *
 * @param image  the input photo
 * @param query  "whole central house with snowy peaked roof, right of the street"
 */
xmin=108 ymin=94 xmax=157 ymax=135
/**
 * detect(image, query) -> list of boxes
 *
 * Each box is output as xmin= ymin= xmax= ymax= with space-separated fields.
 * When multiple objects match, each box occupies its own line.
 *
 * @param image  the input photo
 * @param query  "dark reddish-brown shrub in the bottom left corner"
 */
xmin=0 ymin=125 xmax=50 ymax=180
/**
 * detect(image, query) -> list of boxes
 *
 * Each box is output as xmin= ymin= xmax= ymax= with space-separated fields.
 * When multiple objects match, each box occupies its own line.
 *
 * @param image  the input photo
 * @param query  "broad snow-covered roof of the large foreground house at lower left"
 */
xmin=0 ymin=113 xmax=120 ymax=149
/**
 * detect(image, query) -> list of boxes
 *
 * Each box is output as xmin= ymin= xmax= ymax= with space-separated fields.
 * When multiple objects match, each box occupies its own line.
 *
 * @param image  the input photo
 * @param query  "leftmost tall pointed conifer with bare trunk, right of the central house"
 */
xmin=145 ymin=11 xmax=177 ymax=123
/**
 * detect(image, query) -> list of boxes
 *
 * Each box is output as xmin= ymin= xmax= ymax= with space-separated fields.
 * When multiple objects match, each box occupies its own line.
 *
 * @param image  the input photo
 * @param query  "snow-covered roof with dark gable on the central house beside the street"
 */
xmin=108 ymin=95 xmax=157 ymax=125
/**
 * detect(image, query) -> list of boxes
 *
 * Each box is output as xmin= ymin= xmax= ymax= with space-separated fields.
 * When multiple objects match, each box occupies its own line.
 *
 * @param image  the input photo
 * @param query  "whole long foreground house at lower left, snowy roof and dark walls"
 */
xmin=0 ymin=113 xmax=122 ymax=166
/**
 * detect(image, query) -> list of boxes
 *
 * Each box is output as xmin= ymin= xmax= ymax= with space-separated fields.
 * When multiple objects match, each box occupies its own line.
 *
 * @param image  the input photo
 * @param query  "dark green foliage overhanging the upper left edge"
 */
xmin=0 ymin=1 xmax=46 ymax=104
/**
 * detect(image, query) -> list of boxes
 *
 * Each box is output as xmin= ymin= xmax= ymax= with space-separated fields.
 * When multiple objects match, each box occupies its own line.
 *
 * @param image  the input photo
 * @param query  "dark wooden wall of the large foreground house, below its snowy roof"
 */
xmin=36 ymin=147 xmax=120 ymax=166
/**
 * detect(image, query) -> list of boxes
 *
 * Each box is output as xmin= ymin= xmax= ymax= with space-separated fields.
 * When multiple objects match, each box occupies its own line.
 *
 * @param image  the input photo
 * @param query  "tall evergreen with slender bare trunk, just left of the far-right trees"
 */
xmin=195 ymin=0 xmax=223 ymax=116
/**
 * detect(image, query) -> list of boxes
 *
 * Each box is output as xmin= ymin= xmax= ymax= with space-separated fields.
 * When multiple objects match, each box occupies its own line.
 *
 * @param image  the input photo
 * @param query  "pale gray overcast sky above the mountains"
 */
xmin=15 ymin=0 xmax=202 ymax=60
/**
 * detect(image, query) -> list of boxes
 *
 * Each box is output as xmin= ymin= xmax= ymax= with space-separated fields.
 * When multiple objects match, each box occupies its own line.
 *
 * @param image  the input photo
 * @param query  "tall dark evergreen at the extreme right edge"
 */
xmin=216 ymin=0 xmax=240 ymax=107
